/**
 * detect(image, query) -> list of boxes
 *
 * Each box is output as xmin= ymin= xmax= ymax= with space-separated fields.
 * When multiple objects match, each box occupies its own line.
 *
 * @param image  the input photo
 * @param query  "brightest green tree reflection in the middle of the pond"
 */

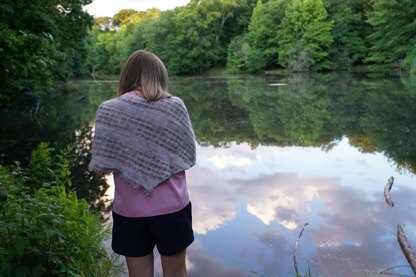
xmin=231 ymin=75 xmax=330 ymax=145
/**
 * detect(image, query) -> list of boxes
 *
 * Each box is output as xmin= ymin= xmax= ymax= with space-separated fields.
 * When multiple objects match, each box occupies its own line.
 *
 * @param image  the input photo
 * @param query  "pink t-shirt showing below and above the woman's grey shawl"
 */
xmin=109 ymin=91 xmax=189 ymax=217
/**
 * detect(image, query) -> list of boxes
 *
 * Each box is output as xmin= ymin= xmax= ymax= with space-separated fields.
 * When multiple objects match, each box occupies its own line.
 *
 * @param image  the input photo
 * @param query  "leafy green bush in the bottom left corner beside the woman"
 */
xmin=0 ymin=144 xmax=120 ymax=276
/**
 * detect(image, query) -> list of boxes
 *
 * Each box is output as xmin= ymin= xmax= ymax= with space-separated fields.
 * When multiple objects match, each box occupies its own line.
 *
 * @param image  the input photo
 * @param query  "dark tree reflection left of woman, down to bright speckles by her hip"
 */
xmin=0 ymin=82 xmax=116 ymax=211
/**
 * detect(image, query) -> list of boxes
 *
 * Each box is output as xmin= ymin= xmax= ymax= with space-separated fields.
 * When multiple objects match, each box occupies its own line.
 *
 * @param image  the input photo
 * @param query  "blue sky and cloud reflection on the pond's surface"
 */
xmin=187 ymin=139 xmax=416 ymax=276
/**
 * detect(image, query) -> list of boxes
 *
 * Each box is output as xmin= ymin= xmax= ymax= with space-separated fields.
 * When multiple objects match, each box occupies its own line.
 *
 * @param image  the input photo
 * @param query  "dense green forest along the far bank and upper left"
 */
xmin=0 ymin=0 xmax=416 ymax=105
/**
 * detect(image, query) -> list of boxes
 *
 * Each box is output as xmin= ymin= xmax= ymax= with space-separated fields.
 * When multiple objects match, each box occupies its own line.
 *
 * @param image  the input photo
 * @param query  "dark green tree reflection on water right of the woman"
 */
xmin=172 ymin=74 xmax=416 ymax=172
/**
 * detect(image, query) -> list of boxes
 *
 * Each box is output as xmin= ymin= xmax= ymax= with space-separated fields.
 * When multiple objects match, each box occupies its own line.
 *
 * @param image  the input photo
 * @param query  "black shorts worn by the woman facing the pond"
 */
xmin=111 ymin=203 xmax=194 ymax=257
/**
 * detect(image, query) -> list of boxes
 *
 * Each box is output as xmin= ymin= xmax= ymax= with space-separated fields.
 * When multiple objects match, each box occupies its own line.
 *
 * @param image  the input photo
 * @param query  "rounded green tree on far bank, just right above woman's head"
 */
xmin=146 ymin=0 xmax=238 ymax=73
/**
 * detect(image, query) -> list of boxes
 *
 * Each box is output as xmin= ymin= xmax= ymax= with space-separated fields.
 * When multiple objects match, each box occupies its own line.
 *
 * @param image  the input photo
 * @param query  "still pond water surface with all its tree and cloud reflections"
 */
xmin=0 ymin=74 xmax=416 ymax=277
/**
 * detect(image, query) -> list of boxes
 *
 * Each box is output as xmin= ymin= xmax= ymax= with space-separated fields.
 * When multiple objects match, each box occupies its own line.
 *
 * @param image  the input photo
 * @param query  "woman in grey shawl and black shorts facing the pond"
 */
xmin=90 ymin=50 xmax=195 ymax=277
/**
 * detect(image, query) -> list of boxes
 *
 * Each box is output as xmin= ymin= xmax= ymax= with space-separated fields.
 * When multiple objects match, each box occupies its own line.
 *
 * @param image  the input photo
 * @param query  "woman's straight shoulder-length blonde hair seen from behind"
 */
xmin=118 ymin=50 xmax=171 ymax=101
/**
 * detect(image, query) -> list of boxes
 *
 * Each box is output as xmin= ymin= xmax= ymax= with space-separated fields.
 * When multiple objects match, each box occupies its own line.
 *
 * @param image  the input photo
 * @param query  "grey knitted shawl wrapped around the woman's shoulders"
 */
xmin=89 ymin=92 xmax=195 ymax=194
